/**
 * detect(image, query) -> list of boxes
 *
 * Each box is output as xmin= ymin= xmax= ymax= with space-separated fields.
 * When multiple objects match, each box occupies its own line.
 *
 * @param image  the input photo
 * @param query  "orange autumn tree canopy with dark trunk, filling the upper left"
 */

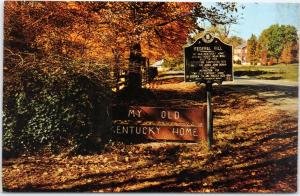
xmin=5 ymin=2 xmax=237 ymax=87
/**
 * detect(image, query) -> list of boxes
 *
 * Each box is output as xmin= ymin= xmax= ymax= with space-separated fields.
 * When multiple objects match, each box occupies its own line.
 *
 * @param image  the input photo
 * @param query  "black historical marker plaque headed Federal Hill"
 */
xmin=184 ymin=34 xmax=233 ymax=83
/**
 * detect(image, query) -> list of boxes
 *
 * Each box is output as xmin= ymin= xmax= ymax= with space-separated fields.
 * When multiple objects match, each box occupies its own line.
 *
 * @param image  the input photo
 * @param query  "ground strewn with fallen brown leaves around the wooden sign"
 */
xmin=3 ymin=80 xmax=298 ymax=193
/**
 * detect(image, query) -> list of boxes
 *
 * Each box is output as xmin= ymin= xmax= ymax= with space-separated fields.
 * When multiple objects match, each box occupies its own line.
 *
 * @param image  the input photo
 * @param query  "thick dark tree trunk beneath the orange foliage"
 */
xmin=127 ymin=43 xmax=142 ymax=90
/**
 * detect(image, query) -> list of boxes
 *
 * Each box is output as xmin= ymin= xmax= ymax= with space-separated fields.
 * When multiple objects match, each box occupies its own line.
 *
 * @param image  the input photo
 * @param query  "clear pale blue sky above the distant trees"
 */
xmin=230 ymin=3 xmax=300 ymax=40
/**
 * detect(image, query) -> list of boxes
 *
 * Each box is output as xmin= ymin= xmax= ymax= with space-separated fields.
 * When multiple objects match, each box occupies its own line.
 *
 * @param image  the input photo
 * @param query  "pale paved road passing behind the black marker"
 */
xmin=159 ymin=76 xmax=298 ymax=116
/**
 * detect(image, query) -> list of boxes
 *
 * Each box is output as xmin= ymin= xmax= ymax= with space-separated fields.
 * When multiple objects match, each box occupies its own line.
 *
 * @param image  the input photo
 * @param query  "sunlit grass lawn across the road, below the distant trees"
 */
xmin=233 ymin=64 xmax=298 ymax=81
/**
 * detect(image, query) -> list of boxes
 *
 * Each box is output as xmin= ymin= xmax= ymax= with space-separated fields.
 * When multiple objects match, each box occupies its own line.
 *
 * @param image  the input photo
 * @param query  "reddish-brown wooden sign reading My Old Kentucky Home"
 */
xmin=110 ymin=105 xmax=208 ymax=142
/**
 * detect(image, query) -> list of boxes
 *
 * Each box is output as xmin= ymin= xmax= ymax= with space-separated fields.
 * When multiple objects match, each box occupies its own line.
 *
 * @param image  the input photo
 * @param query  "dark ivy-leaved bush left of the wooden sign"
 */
xmin=3 ymin=54 xmax=112 ymax=155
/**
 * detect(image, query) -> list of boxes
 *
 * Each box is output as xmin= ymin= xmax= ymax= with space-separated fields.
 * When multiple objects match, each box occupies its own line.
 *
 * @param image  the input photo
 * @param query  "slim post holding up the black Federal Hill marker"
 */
xmin=206 ymin=83 xmax=213 ymax=148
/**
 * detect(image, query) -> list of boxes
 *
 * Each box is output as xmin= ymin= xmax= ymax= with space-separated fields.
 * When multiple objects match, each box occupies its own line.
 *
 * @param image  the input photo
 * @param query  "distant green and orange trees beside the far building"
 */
xmin=246 ymin=24 xmax=299 ymax=65
